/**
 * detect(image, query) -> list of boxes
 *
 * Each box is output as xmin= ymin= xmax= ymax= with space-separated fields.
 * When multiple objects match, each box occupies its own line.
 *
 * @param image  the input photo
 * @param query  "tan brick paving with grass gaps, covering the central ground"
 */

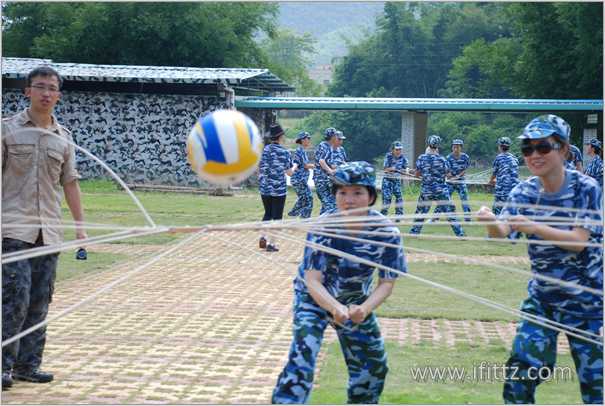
xmin=2 ymin=232 xmax=568 ymax=404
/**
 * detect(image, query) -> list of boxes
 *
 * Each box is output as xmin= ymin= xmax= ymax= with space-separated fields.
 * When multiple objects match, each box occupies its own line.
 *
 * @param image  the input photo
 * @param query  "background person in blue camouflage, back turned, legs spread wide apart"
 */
xmin=410 ymin=135 xmax=464 ymax=237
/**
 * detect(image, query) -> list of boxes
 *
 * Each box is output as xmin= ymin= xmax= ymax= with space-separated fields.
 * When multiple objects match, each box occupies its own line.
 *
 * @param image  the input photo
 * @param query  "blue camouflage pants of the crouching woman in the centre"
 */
xmin=271 ymin=292 xmax=388 ymax=404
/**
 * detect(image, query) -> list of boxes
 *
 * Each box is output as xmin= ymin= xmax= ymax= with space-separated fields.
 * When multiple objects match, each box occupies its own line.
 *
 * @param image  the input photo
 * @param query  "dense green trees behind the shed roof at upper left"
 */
xmin=2 ymin=2 xmax=278 ymax=67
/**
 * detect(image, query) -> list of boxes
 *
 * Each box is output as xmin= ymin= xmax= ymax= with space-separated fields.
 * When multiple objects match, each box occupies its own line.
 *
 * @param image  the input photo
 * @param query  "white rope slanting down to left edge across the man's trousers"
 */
xmin=2 ymin=231 xmax=204 ymax=347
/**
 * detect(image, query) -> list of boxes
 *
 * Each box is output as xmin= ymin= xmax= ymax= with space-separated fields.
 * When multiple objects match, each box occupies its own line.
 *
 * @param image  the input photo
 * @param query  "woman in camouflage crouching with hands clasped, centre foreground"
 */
xmin=271 ymin=162 xmax=407 ymax=404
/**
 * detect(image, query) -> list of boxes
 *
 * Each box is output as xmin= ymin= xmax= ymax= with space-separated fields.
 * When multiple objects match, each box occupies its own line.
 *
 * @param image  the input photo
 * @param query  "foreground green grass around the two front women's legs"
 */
xmin=310 ymin=342 xmax=581 ymax=404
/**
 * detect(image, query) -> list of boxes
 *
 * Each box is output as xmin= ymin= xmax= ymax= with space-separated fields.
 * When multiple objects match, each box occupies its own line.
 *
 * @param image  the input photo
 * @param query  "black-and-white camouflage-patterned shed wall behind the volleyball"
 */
xmin=2 ymin=88 xmax=234 ymax=186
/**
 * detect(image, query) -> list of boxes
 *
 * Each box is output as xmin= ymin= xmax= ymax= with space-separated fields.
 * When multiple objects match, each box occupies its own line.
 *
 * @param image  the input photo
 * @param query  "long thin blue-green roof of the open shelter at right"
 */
xmin=235 ymin=97 xmax=603 ymax=112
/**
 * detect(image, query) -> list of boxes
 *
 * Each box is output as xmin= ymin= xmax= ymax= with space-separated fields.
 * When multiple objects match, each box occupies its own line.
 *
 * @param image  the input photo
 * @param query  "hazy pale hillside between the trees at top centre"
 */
xmin=278 ymin=2 xmax=384 ymax=68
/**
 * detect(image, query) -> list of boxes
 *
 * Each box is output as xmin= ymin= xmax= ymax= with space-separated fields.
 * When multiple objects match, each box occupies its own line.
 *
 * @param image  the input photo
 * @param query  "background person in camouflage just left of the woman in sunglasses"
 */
xmin=488 ymin=137 xmax=519 ymax=215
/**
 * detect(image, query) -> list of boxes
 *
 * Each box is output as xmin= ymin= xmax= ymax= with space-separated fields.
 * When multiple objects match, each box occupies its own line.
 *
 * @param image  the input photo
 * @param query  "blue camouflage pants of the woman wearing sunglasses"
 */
xmin=503 ymin=297 xmax=603 ymax=404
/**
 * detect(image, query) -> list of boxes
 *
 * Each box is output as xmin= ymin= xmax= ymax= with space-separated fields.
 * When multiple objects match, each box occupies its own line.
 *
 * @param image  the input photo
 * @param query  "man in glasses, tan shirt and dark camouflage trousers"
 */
xmin=2 ymin=66 xmax=86 ymax=390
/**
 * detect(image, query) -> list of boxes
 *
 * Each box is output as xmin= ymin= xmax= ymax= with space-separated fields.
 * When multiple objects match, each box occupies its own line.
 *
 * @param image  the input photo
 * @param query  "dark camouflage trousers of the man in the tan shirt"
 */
xmin=2 ymin=238 xmax=59 ymax=371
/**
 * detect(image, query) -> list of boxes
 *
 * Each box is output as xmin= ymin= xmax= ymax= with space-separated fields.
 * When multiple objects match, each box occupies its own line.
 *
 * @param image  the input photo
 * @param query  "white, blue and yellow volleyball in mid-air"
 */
xmin=187 ymin=110 xmax=263 ymax=185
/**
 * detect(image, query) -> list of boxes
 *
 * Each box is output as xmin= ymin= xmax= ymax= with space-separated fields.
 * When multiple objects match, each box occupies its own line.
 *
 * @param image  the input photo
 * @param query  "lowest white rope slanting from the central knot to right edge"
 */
xmin=272 ymin=231 xmax=603 ymax=346
